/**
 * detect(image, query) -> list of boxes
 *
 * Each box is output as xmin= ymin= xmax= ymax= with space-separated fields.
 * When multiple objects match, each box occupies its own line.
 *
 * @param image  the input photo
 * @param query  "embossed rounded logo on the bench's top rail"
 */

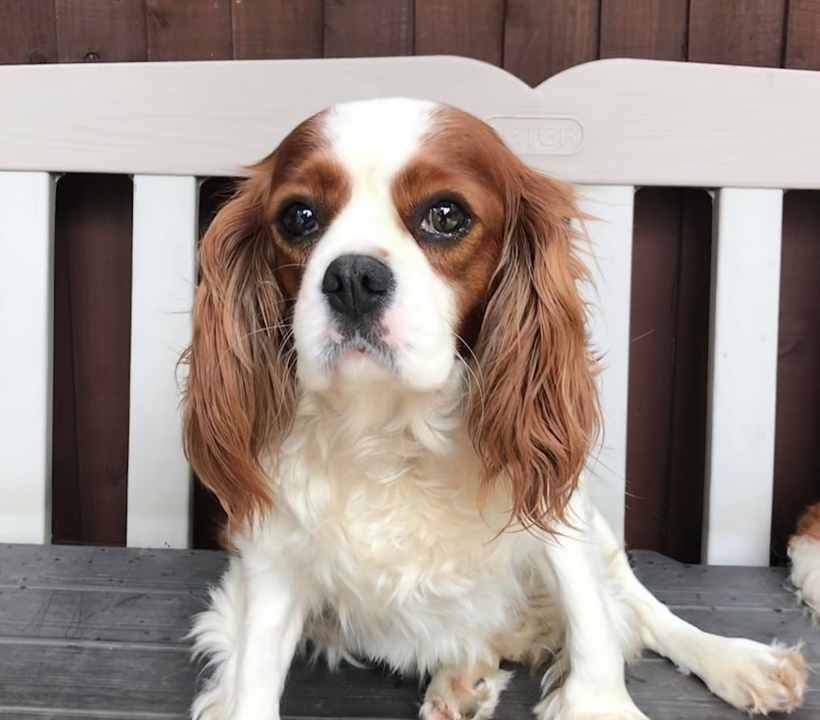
xmin=487 ymin=115 xmax=584 ymax=155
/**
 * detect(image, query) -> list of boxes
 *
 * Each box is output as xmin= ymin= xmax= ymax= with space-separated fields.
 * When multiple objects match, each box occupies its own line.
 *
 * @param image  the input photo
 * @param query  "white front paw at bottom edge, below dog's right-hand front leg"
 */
xmin=534 ymin=677 xmax=648 ymax=720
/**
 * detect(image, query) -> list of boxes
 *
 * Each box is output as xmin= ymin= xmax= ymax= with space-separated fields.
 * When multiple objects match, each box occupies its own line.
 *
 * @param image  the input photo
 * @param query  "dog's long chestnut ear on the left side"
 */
xmin=183 ymin=178 xmax=295 ymax=531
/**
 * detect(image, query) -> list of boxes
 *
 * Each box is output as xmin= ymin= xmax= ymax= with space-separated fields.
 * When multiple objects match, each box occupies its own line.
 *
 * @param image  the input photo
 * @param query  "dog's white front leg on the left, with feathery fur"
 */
xmin=192 ymin=557 xmax=304 ymax=720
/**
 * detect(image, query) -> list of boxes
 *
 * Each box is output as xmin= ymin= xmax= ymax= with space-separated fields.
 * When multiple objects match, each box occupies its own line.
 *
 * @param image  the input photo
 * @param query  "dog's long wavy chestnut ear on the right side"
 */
xmin=469 ymin=167 xmax=599 ymax=531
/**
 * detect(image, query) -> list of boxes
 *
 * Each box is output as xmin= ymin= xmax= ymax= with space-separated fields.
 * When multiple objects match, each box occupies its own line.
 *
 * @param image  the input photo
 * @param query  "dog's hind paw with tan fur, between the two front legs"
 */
xmin=420 ymin=663 xmax=512 ymax=720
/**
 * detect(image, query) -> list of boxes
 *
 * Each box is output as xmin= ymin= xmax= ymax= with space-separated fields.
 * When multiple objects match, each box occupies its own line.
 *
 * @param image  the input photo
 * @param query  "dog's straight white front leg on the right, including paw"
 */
xmin=535 ymin=488 xmax=646 ymax=720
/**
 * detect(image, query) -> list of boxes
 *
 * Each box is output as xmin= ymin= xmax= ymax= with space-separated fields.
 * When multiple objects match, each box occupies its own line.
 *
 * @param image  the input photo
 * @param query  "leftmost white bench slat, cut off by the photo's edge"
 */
xmin=0 ymin=172 xmax=54 ymax=543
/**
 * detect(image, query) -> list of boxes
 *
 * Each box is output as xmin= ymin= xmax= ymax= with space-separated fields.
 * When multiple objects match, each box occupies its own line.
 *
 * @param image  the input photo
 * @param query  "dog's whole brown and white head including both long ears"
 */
xmin=185 ymin=99 xmax=598 ymax=528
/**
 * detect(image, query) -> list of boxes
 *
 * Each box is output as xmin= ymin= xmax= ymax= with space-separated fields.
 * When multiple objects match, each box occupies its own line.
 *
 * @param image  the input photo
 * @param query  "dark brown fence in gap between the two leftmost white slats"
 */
xmin=52 ymin=175 xmax=133 ymax=544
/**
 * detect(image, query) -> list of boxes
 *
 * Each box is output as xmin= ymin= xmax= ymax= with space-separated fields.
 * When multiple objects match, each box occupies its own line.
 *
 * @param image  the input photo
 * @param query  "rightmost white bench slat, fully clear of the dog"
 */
xmin=704 ymin=188 xmax=783 ymax=565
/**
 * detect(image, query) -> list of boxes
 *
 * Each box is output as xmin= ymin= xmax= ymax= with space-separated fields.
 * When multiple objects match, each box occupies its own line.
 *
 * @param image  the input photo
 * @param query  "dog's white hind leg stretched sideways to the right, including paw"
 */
xmin=595 ymin=512 xmax=807 ymax=715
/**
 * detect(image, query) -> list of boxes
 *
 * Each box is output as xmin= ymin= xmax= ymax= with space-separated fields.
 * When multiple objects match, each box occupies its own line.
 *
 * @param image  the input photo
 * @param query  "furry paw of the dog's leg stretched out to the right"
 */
xmin=703 ymin=638 xmax=808 ymax=715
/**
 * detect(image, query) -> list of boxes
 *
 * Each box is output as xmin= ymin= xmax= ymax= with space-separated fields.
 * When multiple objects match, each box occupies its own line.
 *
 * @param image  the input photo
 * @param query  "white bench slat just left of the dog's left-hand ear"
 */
xmin=127 ymin=175 xmax=198 ymax=548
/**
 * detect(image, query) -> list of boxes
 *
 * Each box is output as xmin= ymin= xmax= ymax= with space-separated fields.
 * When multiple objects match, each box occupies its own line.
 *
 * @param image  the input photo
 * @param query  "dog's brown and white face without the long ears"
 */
xmin=258 ymin=100 xmax=505 ymax=391
